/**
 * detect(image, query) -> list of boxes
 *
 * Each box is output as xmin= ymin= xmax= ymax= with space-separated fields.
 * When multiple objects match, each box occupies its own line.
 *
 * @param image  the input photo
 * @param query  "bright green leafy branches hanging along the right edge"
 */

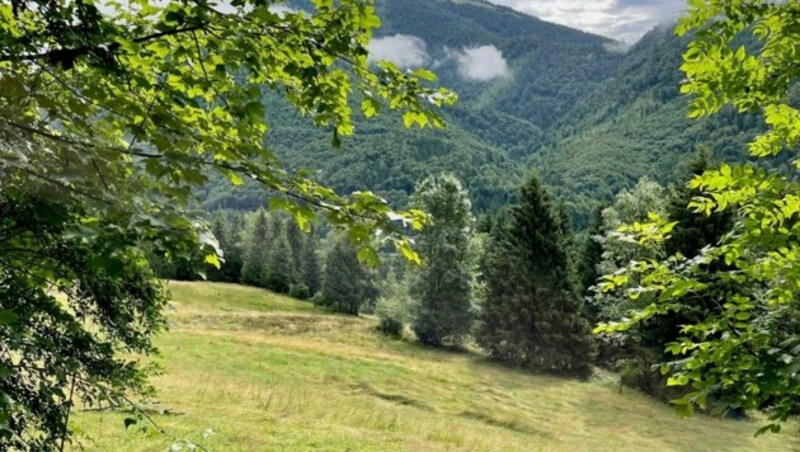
xmin=598 ymin=0 xmax=800 ymax=432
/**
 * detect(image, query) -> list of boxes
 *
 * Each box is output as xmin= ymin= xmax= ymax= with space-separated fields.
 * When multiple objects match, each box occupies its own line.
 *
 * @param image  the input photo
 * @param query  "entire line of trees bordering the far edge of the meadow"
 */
xmin=175 ymin=151 xmax=730 ymax=388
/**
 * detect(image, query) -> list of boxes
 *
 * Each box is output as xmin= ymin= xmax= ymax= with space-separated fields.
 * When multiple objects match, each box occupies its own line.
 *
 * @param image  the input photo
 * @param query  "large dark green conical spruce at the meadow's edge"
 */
xmin=477 ymin=177 xmax=592 ymax=378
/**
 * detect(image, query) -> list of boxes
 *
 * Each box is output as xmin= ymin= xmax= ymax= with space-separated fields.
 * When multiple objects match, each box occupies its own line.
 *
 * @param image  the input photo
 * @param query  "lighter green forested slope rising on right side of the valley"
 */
xmin=527 ymin=27 xmax=759 ymax=226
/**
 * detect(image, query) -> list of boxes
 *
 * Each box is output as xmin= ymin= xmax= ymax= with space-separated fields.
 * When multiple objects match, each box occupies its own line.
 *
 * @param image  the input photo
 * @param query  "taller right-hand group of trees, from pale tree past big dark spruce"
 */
xmin=370 ymin=157 xmax=731 ymax=384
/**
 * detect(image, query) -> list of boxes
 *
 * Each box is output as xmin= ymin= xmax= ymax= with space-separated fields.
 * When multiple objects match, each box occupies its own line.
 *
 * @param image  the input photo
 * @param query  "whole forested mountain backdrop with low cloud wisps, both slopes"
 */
xmin=201 ymin=0 xmax=757 ymax=228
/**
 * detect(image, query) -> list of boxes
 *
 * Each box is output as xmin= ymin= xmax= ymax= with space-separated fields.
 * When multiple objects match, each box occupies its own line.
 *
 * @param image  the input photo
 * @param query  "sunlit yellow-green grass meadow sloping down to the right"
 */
xmin=74 ymin=282 xmax=800 ymax=451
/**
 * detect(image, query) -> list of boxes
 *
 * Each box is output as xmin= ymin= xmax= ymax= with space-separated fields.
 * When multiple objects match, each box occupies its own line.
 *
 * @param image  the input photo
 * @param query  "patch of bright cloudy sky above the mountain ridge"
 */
xmin=489 ymin=0 xmax=686 ymax=43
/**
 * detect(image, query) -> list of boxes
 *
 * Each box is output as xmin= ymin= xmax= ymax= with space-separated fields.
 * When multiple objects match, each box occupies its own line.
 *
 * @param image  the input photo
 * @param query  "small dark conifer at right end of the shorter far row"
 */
xmin=317 ymin=234 xmax=378 ymax=315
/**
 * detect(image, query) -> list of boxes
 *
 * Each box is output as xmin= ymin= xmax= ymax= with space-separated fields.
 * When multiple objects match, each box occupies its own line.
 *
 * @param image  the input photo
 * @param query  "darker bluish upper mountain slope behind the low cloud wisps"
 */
xmin=378 ymin=0 xmax=620 ymax=131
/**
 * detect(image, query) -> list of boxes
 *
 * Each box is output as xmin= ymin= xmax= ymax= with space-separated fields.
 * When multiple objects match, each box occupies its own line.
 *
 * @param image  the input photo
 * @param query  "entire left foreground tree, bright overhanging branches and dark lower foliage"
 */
xmin=0 ymin=0 xmax=455 ymax=444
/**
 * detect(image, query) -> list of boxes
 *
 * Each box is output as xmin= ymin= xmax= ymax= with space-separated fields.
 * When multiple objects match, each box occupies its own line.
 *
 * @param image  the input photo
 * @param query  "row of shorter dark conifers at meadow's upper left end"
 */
xmin=157 ymin=209 xmax=388 ymax=315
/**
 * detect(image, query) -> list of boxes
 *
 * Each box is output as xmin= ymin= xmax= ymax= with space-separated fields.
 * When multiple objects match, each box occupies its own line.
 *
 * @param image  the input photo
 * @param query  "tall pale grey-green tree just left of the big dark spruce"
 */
xmin=411 ymin=174 xmax=475 ymax=346
